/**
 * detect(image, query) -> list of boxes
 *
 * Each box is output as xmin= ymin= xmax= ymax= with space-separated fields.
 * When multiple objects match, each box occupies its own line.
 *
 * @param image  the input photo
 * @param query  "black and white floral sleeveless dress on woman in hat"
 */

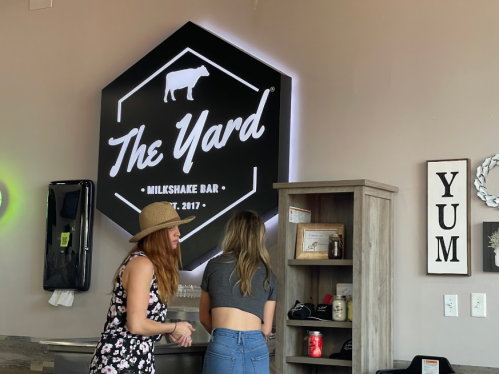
xmin=90 ymin=251 xmax=166 ymax=374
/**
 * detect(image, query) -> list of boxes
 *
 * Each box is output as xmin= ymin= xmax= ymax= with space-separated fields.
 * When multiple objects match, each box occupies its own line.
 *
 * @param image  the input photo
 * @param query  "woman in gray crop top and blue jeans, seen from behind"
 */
xmin=199 ymin=212 xmax=277 ymax=374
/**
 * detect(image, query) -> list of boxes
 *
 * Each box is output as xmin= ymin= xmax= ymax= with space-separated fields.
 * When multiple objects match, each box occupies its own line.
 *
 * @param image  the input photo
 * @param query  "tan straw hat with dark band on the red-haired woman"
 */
xmin=130 ymin=201 xmax=196 ymax=243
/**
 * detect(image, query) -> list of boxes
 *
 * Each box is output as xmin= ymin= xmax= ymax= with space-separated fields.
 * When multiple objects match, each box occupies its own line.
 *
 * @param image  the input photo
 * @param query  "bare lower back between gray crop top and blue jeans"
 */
xmin=211 ymin=308 xmax=262 ymax=331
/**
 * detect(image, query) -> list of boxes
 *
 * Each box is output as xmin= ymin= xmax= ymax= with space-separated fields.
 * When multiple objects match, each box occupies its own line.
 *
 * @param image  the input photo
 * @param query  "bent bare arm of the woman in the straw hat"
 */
xmin=123 ymin=257 xmax=195 ymax=337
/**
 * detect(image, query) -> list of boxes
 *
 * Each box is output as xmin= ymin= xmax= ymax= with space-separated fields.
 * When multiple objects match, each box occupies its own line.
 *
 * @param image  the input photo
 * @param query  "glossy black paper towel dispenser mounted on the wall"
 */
xmin=43 ymin=180 xmax=94 ymax=291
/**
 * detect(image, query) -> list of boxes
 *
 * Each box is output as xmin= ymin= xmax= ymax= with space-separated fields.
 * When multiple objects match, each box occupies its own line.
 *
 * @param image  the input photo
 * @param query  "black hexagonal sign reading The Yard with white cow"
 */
xmin=97 ymin=22 xmax=291 ymax=270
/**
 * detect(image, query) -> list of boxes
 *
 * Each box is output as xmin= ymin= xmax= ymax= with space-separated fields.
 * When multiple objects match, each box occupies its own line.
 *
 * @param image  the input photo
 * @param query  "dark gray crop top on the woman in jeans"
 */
xmin=201 ymin=254 xmax=277 ymax=323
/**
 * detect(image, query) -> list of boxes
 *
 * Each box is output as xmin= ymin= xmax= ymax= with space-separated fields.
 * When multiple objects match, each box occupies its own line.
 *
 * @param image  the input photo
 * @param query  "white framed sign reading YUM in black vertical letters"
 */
xmin=426 ymin=159 xmax=471 ymax=276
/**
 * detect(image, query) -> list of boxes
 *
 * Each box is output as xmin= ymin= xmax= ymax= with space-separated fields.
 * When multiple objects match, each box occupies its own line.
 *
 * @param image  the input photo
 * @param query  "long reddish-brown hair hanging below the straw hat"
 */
xmin=113 ymin=228 xmax=182 ymax=304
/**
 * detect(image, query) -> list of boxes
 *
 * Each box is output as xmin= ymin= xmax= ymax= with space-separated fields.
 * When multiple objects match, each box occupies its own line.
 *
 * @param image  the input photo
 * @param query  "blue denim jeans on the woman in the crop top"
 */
xmin=203 ymin=328 xmax=269 ymax=374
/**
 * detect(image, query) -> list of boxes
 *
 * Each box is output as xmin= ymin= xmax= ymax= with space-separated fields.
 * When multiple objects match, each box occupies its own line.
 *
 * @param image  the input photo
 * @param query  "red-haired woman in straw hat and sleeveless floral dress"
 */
xmin=90 ymin=202 xmax=195 ymax=374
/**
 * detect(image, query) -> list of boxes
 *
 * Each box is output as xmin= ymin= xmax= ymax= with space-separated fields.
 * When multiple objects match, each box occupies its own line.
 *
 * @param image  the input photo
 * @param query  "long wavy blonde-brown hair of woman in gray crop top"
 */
xmin=222 ymin=211 xmax=271 ymax=296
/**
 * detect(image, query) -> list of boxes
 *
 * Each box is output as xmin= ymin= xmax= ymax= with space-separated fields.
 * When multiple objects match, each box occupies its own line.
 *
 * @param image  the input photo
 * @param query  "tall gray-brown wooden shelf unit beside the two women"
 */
xmin=274 ymin=180 xmax=398 ymax=374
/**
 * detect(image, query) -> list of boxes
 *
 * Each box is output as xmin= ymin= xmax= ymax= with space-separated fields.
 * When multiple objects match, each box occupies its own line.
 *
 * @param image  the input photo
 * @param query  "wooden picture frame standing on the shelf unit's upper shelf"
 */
xmin=295 ymin=223 xmax=345 ymax=260
